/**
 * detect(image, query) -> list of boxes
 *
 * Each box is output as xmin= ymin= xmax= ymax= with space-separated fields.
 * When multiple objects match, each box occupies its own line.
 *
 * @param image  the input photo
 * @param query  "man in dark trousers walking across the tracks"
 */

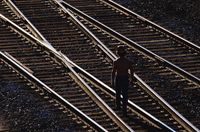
xmin=112 ymin=46 xmax=133 ymax=116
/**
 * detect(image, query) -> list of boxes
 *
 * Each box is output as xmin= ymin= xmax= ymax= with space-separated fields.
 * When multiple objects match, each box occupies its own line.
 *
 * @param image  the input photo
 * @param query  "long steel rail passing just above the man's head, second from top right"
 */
xmin=61 ymin=1 xmax=200 ymax=86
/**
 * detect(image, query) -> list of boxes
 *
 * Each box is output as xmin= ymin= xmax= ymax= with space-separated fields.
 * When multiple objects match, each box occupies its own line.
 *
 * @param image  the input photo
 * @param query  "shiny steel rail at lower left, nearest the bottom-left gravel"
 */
xmin=0 ymin=51 xmax=107 ymax=132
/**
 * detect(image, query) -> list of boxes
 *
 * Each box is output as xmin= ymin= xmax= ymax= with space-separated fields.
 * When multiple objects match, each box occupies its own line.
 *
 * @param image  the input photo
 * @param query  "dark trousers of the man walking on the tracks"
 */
xmin=115 ymin=76 xmax=129 ymax=115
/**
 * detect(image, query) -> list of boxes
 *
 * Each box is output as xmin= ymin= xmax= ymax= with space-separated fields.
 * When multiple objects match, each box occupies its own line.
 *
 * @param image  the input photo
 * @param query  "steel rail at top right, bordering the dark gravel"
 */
xmin=100 ymin=0 xmax=200 ymax=52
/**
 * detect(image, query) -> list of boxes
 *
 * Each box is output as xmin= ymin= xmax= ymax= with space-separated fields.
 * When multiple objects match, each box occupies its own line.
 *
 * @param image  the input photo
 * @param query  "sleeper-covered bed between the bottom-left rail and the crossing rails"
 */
xmin=1 ymin=14 xmax=129 ymax=130
